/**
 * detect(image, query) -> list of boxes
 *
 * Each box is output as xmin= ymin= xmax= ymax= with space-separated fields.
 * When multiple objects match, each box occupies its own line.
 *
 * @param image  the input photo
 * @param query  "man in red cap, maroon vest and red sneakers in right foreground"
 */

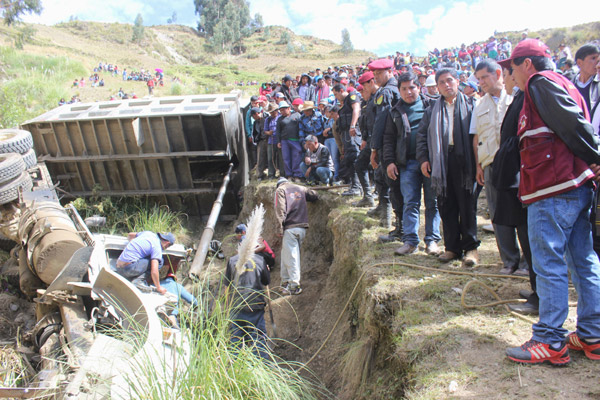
xmin=500 ymin=39 xmax=600 ymax=365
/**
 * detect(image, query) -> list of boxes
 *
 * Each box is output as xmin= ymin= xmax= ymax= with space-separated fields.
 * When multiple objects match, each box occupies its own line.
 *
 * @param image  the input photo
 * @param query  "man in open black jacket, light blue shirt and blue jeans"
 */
xmin=383 ymin=72 xmax=441 ymax=255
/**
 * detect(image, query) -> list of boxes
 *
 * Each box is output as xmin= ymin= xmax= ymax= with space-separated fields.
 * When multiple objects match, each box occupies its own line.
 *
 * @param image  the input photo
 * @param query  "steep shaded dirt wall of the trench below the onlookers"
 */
xmin=239 ymin=183 xmax=404 ymax=399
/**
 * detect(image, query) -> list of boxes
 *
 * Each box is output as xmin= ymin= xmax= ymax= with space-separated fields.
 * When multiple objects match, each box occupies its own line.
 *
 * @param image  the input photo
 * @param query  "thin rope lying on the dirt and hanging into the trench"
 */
xmin=299 ymin=261 xmax=535 ymax=370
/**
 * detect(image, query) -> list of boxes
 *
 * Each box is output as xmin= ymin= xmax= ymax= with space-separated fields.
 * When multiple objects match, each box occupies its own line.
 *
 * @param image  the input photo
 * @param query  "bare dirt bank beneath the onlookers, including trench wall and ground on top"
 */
xmin=240 ymin=183 xmax=600 ymax=399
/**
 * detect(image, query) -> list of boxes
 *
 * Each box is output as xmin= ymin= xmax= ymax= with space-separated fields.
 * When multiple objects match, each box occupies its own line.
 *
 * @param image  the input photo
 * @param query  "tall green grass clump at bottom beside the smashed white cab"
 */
xmin=120 ymin=286 xmax=328 ymax=400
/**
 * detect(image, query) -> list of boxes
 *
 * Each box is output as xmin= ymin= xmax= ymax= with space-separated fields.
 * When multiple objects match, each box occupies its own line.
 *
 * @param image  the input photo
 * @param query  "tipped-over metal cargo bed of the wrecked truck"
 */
xmin=22 ymin=92 xmax=248 ymax=215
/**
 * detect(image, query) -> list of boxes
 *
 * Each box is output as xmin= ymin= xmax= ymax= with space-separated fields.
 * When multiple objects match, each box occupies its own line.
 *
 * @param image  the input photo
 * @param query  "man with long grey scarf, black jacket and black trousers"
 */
xmin=417 ymin=68 xmax=480 ymax=267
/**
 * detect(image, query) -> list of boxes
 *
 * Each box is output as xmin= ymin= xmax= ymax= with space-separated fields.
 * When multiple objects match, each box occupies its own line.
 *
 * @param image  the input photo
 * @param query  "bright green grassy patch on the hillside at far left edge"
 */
xmin=0 ymin=47 xmax=87 ymax=128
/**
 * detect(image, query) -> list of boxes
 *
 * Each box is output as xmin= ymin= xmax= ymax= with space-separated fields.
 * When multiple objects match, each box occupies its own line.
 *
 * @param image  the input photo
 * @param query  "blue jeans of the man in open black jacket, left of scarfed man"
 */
xmin=395 ymin=160 xmax=442 ymax=246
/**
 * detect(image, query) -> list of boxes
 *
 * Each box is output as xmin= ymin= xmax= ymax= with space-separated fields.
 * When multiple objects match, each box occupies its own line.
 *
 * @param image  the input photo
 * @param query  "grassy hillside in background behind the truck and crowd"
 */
xmin=0 ymin=21 xmax=600 ymax=127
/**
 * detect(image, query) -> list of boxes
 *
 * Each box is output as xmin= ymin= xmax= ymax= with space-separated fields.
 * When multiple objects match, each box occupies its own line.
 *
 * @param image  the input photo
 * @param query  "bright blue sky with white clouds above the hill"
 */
xmin=24 ymin=0 xmax=598 ymax=56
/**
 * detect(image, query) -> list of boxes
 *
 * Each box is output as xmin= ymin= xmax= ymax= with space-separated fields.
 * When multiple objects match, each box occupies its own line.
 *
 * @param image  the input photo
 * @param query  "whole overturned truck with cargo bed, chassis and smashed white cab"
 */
xmin=0 ymin=93 xmax=248 ymax=399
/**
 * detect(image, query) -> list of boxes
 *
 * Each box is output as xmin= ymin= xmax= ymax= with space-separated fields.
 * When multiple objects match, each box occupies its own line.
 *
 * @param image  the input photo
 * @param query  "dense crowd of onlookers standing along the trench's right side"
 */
xmin=245 ymin=34 xmax=600 ymax=365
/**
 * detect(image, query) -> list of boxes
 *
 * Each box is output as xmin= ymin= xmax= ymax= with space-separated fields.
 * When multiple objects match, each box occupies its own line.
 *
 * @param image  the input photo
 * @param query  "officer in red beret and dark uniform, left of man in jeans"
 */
xmin=368 ymin=58 xmax=404 ymax=242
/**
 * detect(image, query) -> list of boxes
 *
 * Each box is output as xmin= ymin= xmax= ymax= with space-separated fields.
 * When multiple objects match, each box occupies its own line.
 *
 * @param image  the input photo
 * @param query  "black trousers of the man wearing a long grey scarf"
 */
xmin=438 ymin=151 xmax=479 ymax=255
